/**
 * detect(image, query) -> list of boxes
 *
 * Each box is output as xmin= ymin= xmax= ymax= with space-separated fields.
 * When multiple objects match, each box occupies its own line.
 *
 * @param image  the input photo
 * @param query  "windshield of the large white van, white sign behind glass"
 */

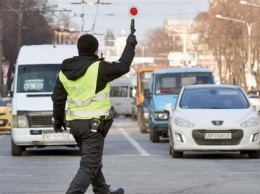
xmin=17 ymin=64 xmax=60 ymax=93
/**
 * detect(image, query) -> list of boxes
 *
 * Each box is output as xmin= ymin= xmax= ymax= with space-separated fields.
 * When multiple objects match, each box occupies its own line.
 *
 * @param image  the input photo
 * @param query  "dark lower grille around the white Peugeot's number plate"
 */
xmin=192 ymin=129 xmax=243 ymax=146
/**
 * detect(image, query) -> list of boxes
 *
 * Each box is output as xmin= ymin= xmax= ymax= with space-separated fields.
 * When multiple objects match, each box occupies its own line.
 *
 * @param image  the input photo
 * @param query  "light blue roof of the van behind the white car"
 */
xmin=153 ymin=67 xmax=211 ymax=74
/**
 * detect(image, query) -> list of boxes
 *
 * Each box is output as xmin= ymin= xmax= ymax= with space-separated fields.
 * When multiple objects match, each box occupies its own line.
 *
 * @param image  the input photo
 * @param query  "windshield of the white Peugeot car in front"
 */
xmin=179 ymin=87 xmax=250 ymax=109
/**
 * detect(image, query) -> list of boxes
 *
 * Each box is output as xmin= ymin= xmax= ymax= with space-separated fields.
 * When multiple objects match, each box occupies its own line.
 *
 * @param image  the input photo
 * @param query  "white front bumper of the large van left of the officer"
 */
xmin=11 ymin=128 xmax=76 ymax=146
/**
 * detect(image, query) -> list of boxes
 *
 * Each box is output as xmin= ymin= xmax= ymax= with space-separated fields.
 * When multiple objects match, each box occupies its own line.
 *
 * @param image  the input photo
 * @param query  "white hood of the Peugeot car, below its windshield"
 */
xmin=174 ymin=107 xmax=259 ymax=128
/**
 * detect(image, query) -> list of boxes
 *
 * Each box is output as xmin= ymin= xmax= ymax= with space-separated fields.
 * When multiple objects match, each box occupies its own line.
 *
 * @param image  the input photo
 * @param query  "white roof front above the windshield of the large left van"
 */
xmin=16 ymin=44 xmax=78 ymax=65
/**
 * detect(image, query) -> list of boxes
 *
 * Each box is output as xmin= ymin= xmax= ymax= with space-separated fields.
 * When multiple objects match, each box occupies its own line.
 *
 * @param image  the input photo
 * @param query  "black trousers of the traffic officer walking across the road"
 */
xmin=66 ymin=120 xmax=108 ymax=194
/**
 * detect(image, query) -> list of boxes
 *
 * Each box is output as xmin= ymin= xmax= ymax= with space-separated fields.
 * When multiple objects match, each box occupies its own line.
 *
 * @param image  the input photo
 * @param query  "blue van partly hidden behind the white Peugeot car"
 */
xmin=146 ymin=67 xmax=215 ymax=142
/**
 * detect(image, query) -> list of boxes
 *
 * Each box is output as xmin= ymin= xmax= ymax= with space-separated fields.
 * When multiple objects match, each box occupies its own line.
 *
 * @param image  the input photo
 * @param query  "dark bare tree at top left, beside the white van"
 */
xmin=0 ymin=0 xmax=54 ymax=89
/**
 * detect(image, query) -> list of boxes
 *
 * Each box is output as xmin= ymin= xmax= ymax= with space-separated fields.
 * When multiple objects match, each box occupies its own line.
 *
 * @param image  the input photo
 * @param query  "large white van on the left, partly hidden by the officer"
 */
xmin=11 ymin=45 xmax=78 ymax=156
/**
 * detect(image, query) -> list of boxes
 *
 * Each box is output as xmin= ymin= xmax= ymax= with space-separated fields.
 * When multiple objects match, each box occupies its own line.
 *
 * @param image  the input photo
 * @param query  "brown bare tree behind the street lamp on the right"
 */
xmin=195 ymin=0 xmax=260 ymax=89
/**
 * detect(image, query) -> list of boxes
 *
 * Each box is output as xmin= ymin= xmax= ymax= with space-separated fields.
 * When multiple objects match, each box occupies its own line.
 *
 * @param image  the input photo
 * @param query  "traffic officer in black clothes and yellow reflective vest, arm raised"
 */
xmin=52 ymin=33 xmax=137 ymax=194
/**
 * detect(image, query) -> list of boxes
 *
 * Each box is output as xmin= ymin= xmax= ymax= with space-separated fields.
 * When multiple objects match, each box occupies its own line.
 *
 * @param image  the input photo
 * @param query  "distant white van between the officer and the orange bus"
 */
xmin=110 ymin=77 xmax=137 ymax=116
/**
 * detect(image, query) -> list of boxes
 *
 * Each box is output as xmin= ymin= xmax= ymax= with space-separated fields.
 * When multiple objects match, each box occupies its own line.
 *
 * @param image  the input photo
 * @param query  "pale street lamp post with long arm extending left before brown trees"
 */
xmin=216 ymin=14 xmax=256 ymax=74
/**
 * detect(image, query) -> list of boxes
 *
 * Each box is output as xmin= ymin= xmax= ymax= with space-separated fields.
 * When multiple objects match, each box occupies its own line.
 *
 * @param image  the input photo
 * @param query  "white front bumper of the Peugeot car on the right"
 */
xmin=172 ymin=127 xmax=260 ymax=151
